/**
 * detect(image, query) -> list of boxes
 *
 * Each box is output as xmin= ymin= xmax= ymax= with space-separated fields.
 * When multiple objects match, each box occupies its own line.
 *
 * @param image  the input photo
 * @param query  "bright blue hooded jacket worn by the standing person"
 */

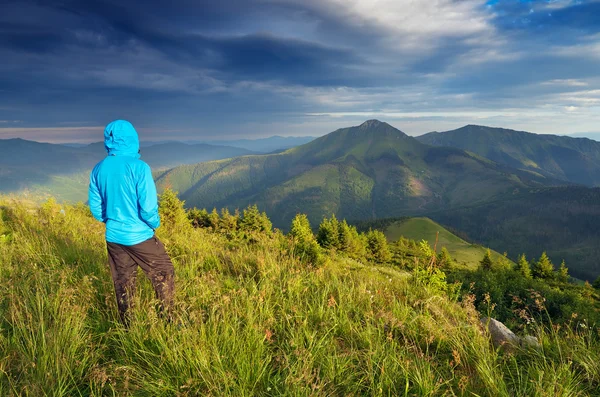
xmin=89 ymin=120 xmax=160 ymax=245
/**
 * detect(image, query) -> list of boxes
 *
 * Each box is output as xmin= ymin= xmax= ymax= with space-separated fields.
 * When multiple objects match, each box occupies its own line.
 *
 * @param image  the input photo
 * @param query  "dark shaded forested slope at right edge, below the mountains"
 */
xmin=428 ymin=186 xmax=600 ymax=281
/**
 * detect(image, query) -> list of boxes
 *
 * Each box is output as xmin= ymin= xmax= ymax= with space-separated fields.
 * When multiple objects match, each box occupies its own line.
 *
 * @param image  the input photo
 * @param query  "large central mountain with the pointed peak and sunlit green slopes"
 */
xmin=157 ymin=120 xmax=554 ymax=228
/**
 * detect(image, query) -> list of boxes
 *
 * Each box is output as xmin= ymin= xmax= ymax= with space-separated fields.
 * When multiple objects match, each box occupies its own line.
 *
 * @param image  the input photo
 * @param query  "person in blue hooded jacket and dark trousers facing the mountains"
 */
xmin=89 ymin=120 xmax=175 ymax=326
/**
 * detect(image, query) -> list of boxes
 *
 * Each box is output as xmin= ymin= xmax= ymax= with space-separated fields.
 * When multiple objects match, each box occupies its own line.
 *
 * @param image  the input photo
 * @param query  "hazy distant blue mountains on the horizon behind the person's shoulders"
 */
xmin=0 ymin=139 xmax=254 ymax=200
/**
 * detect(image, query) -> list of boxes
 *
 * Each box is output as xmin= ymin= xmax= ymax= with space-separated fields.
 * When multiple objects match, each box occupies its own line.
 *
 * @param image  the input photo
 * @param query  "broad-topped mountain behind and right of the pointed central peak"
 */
xmin=417 ymin=125 xmax=600 ymax=186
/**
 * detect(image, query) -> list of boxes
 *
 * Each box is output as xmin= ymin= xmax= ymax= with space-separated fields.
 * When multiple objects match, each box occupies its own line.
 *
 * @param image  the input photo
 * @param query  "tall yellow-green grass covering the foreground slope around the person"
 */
xmin=0 ymin=200 xmax=600 ymax=396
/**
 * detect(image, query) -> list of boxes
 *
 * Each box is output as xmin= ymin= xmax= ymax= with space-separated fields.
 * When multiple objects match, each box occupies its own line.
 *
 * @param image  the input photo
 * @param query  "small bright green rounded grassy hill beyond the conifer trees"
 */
xmin=384 ymin=218 xmax=503 ymax=269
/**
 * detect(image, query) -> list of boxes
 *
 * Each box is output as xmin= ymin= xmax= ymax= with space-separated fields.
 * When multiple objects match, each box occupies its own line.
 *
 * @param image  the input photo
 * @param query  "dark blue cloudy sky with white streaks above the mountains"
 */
xmin=0 ymin=0 xmax=600 ymax=142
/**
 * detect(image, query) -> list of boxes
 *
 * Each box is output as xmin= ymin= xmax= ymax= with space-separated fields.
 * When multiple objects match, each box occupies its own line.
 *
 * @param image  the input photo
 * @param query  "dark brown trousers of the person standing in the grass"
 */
xmin=106 ymin=236 xmax=175 ymax=326
